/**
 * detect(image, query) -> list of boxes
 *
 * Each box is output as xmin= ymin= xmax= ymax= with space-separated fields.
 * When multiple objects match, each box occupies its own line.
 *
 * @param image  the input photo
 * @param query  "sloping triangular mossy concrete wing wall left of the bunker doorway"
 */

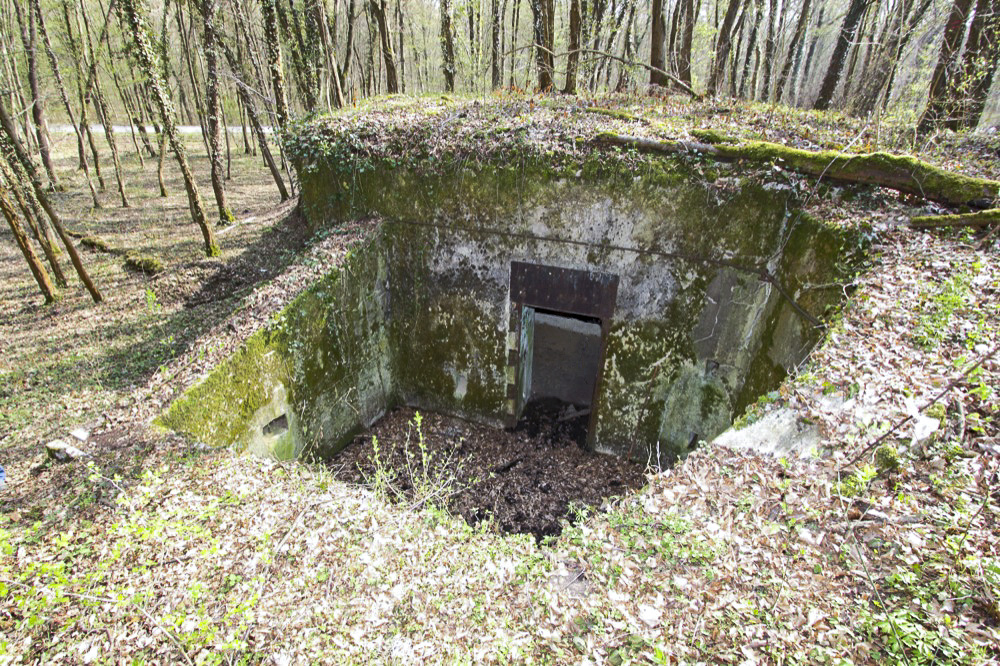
xmin=158 ymin=237 xmax=394 ymax=459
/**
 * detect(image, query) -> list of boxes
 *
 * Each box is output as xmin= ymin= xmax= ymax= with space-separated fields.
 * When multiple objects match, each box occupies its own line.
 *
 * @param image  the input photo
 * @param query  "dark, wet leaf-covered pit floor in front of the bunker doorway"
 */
xmin=329 ymin=402 xmax=646 ymax=541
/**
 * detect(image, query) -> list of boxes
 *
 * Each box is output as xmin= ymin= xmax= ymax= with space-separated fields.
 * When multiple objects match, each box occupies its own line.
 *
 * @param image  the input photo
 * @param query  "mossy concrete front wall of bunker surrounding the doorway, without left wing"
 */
xmin=303 ymin=160 xmax=856 ymax=458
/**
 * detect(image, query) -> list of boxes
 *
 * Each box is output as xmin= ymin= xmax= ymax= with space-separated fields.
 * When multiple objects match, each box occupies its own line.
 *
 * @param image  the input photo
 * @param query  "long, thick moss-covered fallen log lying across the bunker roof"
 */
xmin=594 ymin=132 xmax=1000 ymax=208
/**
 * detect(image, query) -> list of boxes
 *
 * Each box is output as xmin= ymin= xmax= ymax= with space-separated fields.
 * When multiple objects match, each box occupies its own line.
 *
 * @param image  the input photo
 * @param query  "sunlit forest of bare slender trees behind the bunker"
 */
xmin=0 ymin=0 xmax=1000 ymax=301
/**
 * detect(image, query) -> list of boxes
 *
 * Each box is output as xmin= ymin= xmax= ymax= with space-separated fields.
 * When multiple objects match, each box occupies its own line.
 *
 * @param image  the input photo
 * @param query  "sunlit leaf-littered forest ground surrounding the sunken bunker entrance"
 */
xmin=0 ymin=94 xmax=1000 ymax=664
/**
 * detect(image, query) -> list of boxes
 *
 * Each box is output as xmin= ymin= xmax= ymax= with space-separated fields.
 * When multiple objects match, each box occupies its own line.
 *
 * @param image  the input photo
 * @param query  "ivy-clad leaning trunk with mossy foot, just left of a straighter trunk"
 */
xmin=118 ymin=0 xmax=219 ymax=257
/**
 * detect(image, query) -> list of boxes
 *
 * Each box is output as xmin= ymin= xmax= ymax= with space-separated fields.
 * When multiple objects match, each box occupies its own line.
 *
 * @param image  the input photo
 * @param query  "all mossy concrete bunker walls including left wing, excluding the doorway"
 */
xmin=163 ymin=154 xmax=845 ymax=461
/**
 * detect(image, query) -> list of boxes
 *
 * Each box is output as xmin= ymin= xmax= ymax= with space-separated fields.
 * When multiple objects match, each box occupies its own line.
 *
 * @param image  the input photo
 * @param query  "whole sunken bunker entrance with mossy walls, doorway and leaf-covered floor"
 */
xmin=161 ymin=165 xmax=860 ymax=536
